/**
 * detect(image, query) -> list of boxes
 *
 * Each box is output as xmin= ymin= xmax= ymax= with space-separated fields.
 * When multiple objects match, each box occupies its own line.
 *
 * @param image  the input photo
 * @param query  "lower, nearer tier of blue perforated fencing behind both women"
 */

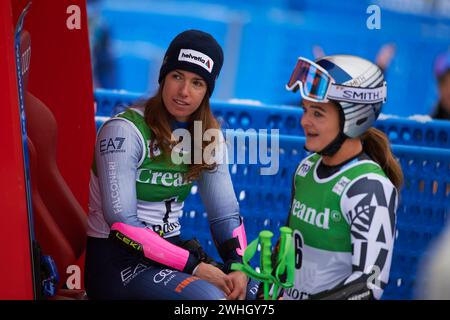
xmin=182 ymin=134 xmax=450 ymax=299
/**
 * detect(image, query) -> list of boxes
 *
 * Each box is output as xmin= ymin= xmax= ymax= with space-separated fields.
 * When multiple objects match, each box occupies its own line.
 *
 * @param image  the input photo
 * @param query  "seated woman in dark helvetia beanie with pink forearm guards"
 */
xmin=85 ymin=30 xmax=256 ymax=300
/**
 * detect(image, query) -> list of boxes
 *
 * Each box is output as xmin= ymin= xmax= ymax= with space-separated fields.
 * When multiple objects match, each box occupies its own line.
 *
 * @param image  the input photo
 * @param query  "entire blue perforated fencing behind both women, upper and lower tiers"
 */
xmin=95 ymin=90 xmax=450 ymax=299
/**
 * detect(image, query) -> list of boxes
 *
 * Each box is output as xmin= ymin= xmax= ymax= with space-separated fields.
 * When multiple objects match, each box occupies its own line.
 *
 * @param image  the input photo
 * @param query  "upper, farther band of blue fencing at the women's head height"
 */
xmin=94 ymin=89 xmax=450 ymax=149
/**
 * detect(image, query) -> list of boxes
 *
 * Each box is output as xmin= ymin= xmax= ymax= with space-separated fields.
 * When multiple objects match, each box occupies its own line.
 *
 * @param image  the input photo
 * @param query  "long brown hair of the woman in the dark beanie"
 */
xmin=144 ymin=84 xmax=220 ymax=181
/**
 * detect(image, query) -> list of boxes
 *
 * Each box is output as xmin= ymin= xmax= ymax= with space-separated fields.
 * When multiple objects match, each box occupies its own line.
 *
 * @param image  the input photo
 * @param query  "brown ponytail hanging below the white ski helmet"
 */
xmin=361 ymin=128 xmax=403 ymax=191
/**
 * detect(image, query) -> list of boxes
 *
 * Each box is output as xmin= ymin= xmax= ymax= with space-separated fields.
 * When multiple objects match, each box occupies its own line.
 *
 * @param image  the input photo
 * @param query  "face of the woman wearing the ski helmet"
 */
xmin=300 ymin=100 xmax=339 ymax=152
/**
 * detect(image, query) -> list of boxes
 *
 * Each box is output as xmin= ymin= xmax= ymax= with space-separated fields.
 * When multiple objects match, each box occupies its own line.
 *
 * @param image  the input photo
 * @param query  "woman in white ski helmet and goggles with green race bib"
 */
xmin=284 ymin=55 xmax=403 ymax=300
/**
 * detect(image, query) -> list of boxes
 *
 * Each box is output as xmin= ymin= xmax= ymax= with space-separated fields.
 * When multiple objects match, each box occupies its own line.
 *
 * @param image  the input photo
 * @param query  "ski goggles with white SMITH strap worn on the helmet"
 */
xmin=286 ymin=57 xmax=387 ymax=104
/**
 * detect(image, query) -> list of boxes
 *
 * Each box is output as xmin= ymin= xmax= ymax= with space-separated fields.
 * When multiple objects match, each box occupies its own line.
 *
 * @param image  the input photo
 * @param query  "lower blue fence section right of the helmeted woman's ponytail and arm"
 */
xmin=384 ymin=145 xmax=450 ymax=299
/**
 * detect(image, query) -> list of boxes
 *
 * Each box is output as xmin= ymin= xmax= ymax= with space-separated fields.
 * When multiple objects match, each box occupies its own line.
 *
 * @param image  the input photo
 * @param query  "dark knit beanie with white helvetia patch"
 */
xmin=158 ymin=30 xmax=223 ymax=96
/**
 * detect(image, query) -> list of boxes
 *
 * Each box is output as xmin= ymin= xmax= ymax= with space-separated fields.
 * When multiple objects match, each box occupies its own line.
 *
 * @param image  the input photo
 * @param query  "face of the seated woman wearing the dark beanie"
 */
xmin=162 ymin=69 xmax=207 ymax=122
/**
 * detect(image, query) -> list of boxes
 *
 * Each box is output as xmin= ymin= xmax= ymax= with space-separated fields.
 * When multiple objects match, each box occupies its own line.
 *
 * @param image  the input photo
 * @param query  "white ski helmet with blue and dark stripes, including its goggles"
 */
xmin=286 ymin=55 xmax=387 ymax=154
